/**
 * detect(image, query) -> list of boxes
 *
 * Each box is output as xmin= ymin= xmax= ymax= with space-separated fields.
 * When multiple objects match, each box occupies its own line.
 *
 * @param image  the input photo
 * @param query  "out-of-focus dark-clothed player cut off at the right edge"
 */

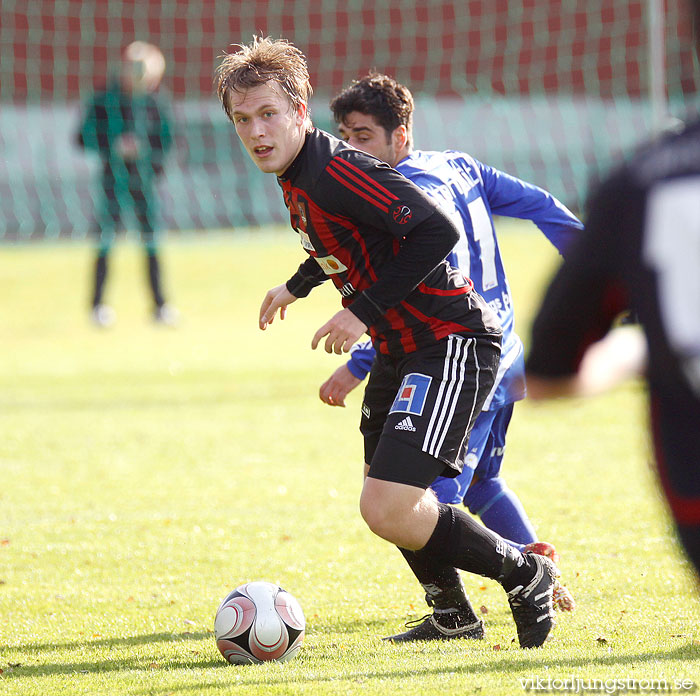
xmin=526 ymin=0 xmax=700 ymax=572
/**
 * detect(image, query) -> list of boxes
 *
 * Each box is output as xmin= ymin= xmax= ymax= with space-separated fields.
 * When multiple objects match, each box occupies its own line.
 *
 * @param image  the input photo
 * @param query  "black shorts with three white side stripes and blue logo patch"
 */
xmin=360 ymin=334 xmax=501 ymax=488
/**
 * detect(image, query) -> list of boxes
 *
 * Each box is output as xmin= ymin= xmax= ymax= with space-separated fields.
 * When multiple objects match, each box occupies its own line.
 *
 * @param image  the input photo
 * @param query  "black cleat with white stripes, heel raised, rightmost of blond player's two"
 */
xmin=508 ymin=552 xmax=559 ymax=648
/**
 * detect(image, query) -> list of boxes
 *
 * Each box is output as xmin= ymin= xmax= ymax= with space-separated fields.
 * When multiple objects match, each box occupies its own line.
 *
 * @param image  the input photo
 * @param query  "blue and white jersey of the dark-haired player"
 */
xmin=348 ymin=150 xmax=583 ymax=409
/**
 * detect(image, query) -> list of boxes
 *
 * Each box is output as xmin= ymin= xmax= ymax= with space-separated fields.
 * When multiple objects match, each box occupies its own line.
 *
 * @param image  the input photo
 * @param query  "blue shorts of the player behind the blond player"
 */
xmin=430 ymin=403 xmax=513 ymax=505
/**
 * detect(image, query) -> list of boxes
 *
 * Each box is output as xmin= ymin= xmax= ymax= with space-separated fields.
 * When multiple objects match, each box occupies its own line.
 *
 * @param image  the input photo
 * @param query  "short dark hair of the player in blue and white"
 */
xmin=330 ymin=72 xmax=413 ymax=146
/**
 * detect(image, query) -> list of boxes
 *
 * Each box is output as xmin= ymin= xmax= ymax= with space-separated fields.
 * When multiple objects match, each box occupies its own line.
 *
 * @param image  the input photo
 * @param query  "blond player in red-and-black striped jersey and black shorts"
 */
xmin=217 ymin=38 xmax=557 ymax=647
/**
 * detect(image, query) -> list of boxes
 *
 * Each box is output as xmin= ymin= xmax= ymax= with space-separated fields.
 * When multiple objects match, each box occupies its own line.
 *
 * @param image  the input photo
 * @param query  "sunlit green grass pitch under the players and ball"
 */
xmin=0 ymin=225 xmax=700 ymax=696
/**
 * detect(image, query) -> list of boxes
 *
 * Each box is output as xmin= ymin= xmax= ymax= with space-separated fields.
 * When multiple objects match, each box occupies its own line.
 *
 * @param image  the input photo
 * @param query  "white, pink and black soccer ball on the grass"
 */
xmin=214 ymin=582 xmax=306 ymax=665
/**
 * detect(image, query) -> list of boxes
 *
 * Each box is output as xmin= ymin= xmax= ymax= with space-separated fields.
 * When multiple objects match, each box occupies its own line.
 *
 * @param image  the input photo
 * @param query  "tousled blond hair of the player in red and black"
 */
xmin=215 ymin=36 xmax=313 ymax=120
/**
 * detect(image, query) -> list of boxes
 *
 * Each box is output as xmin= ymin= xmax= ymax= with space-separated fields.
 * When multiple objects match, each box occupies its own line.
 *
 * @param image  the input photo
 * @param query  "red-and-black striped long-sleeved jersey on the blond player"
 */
xmin=278 ymin=129 xmax=501 ymax=355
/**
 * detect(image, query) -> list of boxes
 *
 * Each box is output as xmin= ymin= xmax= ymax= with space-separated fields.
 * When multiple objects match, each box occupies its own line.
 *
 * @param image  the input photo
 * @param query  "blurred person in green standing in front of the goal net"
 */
xmin=78 ymin=41 xmax=178 ymax=327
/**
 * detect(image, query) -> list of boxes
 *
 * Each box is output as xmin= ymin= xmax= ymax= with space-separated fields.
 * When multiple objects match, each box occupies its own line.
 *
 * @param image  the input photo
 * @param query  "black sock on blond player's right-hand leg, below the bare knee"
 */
xmin=421 ymin=503 xmax=533 ymax=591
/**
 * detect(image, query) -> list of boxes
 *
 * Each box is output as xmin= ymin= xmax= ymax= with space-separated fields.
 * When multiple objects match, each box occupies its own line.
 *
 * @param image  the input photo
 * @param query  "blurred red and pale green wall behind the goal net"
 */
xmin=0 ymin=0 xmax=699 ymax=241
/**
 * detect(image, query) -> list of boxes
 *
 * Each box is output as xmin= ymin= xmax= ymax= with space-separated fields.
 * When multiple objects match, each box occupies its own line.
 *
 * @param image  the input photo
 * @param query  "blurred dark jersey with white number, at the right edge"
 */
xmin=526 ymin=121 xmax=700 ymax=399
